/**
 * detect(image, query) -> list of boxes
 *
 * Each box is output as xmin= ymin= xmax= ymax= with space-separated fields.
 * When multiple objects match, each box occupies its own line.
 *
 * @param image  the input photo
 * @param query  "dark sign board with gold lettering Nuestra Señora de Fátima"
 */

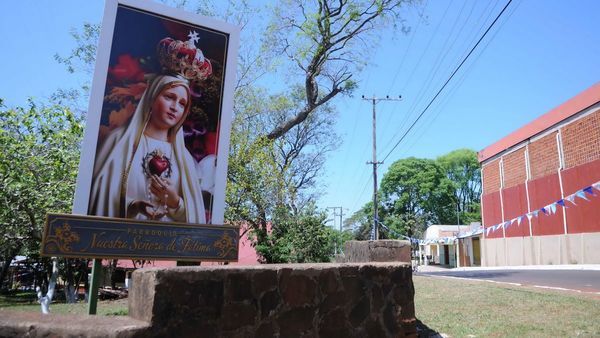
xmin=41 ymin=214 xmax=239 ymax=262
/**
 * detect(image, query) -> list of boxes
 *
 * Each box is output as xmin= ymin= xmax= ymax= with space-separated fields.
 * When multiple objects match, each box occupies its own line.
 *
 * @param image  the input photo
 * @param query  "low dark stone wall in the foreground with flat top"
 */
xmin=129 ymin=263 xmax=416 ymax=337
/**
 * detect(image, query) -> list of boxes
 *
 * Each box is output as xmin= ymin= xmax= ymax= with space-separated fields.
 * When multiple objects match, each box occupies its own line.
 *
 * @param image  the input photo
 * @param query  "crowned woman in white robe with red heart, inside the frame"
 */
xmin=88 ymin=34 xmax=212 ymax=224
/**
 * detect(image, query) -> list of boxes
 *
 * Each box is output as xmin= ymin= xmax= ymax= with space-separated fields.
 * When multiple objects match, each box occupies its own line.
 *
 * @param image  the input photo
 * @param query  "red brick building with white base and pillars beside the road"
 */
xmin=479 ymin=83 xmax=600 ymax=266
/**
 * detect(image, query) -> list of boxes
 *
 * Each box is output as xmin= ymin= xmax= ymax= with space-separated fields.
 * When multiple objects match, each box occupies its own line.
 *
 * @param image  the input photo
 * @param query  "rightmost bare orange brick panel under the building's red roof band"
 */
xmin=561 ymin=110 xmax=600 ymax=169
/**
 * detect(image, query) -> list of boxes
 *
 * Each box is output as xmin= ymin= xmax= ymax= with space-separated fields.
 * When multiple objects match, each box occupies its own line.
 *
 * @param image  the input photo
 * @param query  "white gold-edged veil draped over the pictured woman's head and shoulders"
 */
xmin=88 ymin=75 xmax=206 ymax=224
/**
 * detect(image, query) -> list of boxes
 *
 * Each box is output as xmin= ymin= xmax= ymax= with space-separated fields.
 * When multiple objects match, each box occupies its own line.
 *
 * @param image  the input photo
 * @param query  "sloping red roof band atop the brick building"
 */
xmin=479 ymin=82 xmax=600 ymax=163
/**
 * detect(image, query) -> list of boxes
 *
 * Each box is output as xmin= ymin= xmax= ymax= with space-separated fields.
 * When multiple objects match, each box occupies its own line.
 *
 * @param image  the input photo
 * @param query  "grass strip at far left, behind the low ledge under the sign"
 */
xmin=0 ymin=292 xmax=127 ymax=316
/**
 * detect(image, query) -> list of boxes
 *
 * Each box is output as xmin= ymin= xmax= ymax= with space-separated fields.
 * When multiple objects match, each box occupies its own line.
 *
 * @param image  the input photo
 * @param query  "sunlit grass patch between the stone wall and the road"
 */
xmin=413 ymin=276 xmax=600 ymax=337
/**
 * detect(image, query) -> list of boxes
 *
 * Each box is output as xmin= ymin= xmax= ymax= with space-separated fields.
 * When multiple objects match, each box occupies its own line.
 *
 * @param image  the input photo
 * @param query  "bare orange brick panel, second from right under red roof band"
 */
xmin=529 ymin=132 xmax=560 ymax=180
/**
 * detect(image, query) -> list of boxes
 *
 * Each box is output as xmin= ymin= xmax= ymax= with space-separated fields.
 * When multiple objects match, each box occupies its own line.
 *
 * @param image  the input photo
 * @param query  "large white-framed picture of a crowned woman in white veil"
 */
xmin=73 ymin=0 xmax=239 ymax=224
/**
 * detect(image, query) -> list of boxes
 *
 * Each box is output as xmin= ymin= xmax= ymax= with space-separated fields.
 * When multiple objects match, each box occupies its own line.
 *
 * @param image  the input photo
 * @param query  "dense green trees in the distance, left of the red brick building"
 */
xmin=348 ymin=149 xmax=481 ymax=239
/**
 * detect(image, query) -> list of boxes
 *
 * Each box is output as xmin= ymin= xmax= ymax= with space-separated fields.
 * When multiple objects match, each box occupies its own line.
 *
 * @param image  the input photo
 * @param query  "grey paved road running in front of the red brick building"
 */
xmin=417 ymin=270 xmax=600 ymax=295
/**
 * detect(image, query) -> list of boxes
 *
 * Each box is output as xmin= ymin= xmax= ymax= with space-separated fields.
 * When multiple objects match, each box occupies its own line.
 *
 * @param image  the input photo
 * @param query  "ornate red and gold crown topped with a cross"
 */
xmin=157 ymin=32 xmax=212 ymax=82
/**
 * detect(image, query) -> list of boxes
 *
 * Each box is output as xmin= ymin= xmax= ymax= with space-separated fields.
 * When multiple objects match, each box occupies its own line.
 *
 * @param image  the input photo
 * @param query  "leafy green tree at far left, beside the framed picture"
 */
xmin=0 ymin=101 xmax=83 ymax=288
